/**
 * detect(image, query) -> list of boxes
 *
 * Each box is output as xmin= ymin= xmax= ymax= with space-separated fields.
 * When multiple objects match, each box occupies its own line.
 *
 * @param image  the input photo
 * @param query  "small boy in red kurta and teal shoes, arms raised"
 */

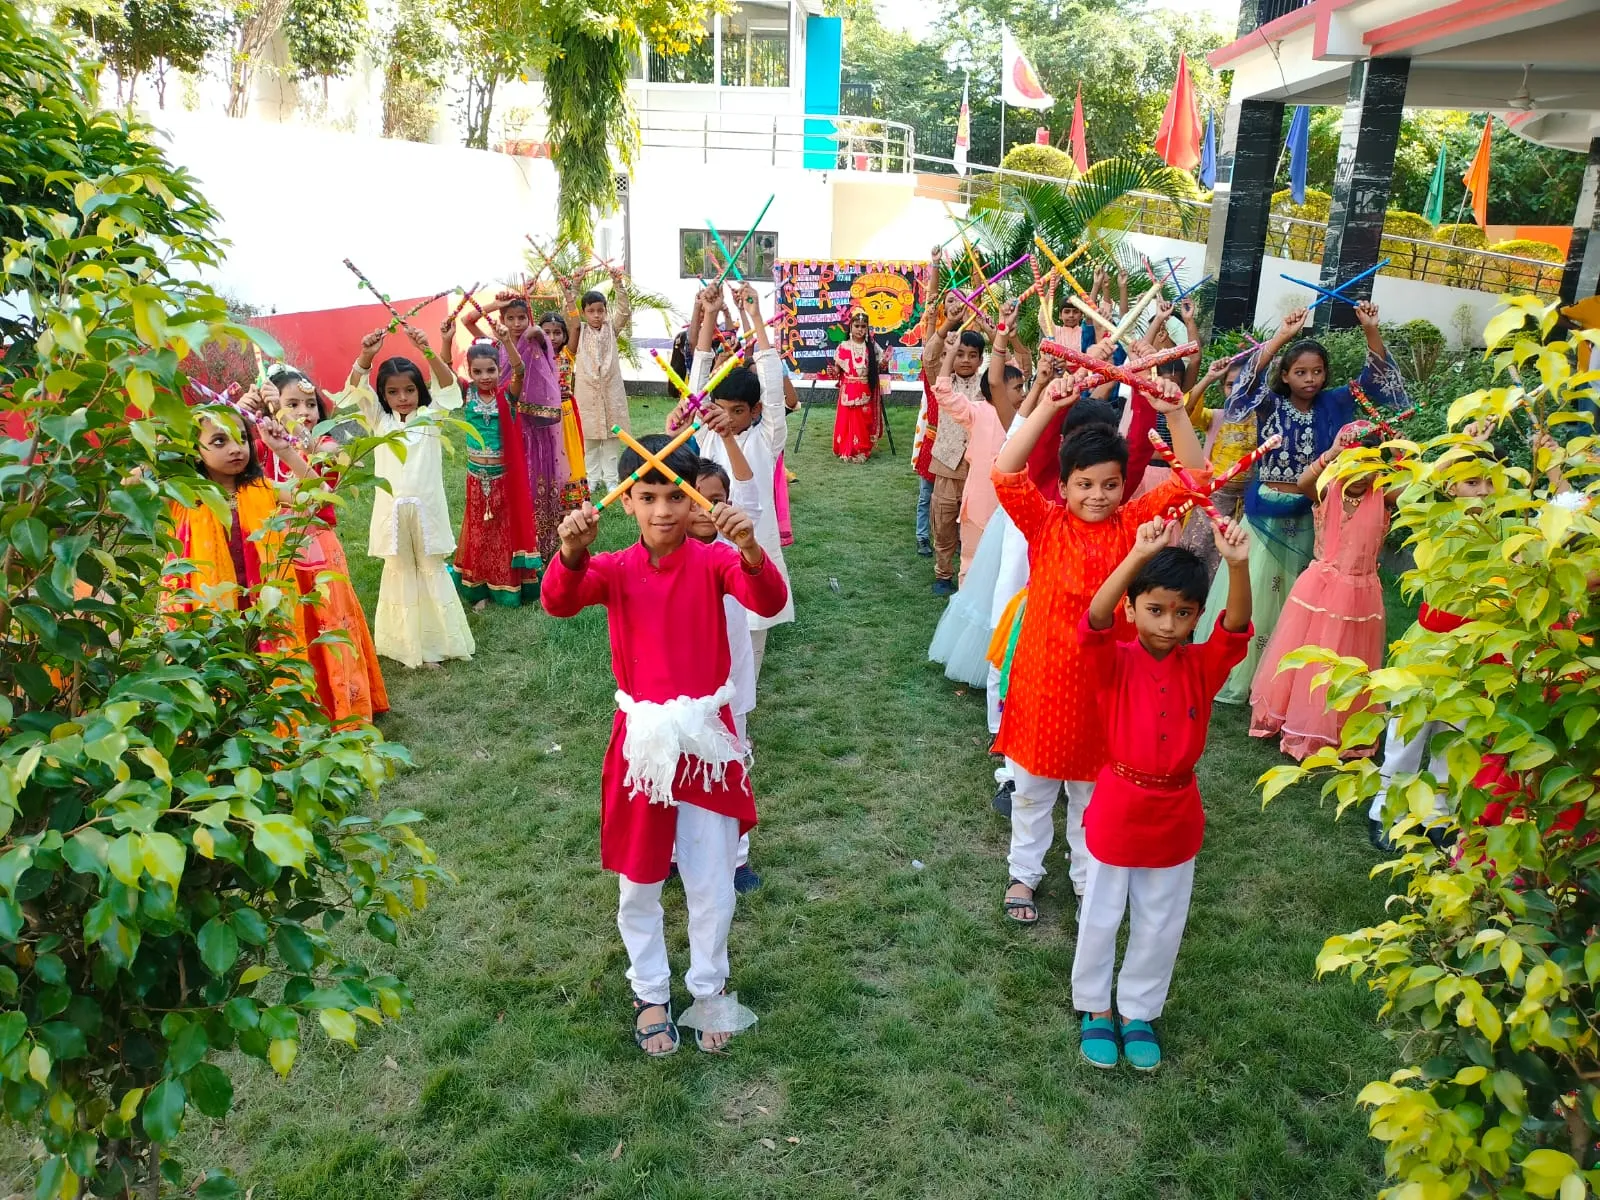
xmin=1072 ymin=517 xmax=1250 ymax=1070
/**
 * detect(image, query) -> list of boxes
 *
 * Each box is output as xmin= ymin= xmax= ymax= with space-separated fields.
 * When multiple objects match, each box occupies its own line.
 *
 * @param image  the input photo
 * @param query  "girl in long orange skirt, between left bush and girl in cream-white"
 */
xmin=245 ymin=366 xmax=389 ymax=726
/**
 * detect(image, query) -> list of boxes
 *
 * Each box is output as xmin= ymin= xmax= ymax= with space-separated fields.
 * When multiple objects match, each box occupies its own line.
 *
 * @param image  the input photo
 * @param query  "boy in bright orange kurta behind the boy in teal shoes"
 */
xmin=994 ymin=376 xmax=1203 ymax=925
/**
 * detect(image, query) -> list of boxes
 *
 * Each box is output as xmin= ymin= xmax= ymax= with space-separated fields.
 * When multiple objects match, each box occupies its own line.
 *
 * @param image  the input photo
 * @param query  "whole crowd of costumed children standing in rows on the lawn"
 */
xmin=171 ymin=240 xmax=1600 ymax=1070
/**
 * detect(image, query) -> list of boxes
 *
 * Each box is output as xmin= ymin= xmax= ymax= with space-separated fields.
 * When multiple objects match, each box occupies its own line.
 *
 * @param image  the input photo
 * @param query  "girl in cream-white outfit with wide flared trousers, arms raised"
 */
xmin=334 ymin=322 xmax=475 ymax=667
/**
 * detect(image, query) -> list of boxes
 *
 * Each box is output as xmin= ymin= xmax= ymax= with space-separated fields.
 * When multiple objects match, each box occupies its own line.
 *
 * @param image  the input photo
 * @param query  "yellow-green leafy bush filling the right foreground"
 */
xmin=1261 ymin=298 xmax=1600 ymax=1200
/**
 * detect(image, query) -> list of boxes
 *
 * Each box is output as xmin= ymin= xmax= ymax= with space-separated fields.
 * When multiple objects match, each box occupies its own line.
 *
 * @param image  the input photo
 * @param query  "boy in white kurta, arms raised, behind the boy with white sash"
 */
xmin=674 ymin=283 xmax=795 ymax=678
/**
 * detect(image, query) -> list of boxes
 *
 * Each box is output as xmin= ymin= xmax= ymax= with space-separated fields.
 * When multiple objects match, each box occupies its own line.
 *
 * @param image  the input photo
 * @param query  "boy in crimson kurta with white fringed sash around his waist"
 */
xmin=541 ymin=434 xmax=789 ymax=1058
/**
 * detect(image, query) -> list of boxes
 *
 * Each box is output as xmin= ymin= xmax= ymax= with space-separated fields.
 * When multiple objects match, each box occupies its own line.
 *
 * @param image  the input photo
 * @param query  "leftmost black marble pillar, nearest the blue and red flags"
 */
xmin=1205 ymin=99 xmax=1283 ymax=330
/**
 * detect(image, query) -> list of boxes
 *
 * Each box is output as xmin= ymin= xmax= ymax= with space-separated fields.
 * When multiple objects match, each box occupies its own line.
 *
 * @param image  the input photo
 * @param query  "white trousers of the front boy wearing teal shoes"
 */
xmin=1072 ymin=858 xmax=1195 ymax=1021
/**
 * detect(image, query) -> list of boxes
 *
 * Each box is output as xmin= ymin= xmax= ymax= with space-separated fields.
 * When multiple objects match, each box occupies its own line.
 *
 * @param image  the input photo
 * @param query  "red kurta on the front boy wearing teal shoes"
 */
xmin=1078 ymin=613 xmax=1253 ymax=867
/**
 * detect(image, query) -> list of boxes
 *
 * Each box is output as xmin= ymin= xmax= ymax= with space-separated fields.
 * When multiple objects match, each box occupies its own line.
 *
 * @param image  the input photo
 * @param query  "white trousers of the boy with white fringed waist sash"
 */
xmin=616 ymin=805 xmax=739 ymax=1005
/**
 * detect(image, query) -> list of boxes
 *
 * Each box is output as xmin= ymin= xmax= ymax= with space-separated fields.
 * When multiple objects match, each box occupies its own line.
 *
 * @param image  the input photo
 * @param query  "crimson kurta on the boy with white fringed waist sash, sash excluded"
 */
xmin=539 ymin=539 xmax=789 ymax=883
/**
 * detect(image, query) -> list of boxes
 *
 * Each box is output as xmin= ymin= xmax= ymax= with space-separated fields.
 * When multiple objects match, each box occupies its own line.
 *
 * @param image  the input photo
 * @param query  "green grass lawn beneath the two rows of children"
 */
xmin=209 ymin=402 xmax=1394 ymax=1200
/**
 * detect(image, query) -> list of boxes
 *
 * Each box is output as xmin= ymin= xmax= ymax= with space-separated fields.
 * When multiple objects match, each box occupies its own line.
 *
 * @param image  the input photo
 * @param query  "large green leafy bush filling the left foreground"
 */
xmin=0 ymin=5 xmax=445 ymax=1200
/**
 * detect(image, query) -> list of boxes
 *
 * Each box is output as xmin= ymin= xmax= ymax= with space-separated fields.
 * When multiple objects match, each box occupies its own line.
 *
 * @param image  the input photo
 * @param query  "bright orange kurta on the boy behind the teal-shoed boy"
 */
xmin=994 ymin=470 xmax=1186 ymax=779
